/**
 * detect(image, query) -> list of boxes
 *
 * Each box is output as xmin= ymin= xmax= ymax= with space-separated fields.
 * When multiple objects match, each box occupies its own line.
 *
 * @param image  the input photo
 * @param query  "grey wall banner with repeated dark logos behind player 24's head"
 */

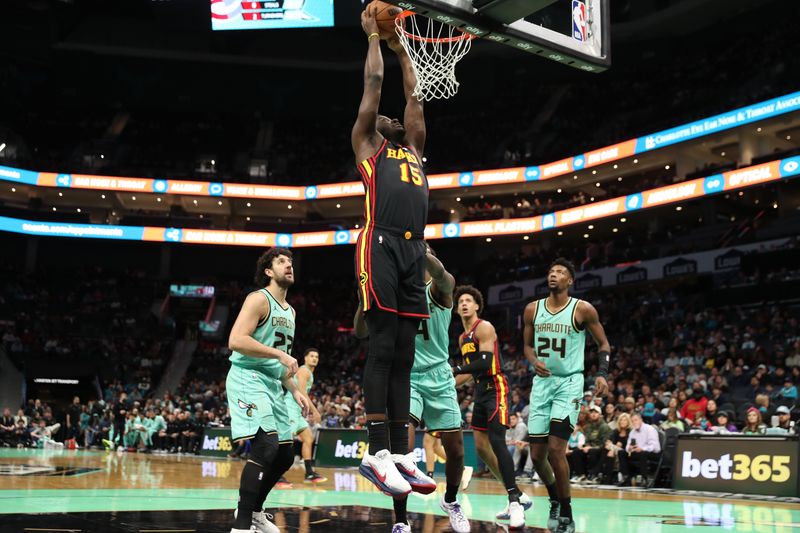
xmin=488 ymin=238 xmax=790 ymax=305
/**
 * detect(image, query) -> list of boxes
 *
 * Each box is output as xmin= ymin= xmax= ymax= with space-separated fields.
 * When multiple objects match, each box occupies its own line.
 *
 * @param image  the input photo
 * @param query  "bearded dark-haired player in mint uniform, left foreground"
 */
xmin=226 ymin=248 xmax=310 ymax=533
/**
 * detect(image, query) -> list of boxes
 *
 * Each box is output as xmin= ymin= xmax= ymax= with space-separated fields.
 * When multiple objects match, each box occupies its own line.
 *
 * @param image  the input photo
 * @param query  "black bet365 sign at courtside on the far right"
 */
xmin=674 ymin=436 xmax=800 ymax=496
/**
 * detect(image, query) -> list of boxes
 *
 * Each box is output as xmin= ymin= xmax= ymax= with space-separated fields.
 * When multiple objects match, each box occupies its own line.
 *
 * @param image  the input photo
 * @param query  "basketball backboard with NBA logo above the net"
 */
xmin=389 ymin=0 xmax=611 ymax=72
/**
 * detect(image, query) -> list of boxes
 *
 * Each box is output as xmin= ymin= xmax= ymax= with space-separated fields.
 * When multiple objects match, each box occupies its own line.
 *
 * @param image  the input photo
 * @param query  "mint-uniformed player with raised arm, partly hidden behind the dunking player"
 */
xmin=355 ymin=247 xmax=470 ymax=533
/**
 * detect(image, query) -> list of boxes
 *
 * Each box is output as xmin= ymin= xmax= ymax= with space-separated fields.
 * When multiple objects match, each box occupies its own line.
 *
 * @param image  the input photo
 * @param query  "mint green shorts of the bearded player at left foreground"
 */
xmin=225 ymin=366 xmax=292 ymax=442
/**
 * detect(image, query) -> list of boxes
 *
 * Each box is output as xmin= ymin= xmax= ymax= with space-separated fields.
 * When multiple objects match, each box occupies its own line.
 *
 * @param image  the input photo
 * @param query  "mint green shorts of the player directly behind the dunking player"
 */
xmin=409 ymin=363 xmax=461 ymax=431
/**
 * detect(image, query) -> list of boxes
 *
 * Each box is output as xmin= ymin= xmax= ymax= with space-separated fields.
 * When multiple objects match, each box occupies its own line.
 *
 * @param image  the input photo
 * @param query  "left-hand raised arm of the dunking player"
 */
xmin=351 ymin=6 xmax=383 ymax=164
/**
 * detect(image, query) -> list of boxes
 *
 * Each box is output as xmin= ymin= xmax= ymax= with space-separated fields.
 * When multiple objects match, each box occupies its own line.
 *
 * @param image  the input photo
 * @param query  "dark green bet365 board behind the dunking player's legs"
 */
xmin=314 ymin=428 xmax=478 ymax=472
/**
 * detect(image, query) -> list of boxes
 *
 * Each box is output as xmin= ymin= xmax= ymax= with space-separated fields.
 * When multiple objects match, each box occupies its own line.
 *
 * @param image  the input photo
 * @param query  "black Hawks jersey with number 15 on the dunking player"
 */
xmin=358 ymin=139 xmax=428 ymax=235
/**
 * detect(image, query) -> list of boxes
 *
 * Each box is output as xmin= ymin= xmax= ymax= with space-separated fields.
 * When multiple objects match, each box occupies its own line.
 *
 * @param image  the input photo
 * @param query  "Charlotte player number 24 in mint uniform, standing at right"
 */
xmin=523 ymin=258 xmax=611 ymax=533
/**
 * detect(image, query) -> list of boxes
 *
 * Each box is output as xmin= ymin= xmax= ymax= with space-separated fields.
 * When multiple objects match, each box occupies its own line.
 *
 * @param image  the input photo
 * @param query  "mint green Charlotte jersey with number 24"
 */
xmin=533 ymin=298 xmax=586 ymax=377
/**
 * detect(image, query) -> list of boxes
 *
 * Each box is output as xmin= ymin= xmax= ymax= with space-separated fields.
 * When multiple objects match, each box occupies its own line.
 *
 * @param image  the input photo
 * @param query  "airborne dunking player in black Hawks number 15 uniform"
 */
xmin=352 ymin=6 xmax=432 ymax=497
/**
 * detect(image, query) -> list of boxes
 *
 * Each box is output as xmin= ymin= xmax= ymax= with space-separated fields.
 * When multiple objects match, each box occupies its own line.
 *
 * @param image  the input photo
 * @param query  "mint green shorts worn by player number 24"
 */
xmin=528 ymin=374 xmax=583 ymax=437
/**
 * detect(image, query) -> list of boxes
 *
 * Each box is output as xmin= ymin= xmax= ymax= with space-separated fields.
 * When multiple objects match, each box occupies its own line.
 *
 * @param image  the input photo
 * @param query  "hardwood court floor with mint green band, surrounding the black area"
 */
xmin=0 ymin=450 xmax=800 ymax=533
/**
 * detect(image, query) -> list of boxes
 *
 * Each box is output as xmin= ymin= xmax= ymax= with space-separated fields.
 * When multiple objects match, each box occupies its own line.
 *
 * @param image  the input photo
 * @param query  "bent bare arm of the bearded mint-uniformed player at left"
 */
xmin=228 ymin=292 xmax=297 ymax=376
